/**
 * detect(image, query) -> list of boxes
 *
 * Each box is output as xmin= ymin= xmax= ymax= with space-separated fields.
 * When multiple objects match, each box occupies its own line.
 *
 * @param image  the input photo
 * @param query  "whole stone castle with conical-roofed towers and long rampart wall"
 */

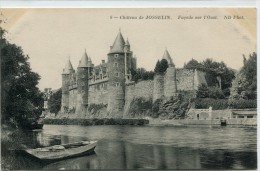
xmin=61 ymin=31 xmax=207 ymax=117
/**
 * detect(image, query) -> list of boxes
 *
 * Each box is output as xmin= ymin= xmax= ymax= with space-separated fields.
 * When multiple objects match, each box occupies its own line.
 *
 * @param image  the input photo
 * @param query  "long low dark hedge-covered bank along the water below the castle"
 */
xmin=44 ymin=118 xmax=149 ymax=126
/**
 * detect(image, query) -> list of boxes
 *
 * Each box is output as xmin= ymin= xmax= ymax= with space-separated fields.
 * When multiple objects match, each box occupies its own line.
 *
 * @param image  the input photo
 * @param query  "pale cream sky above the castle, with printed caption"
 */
xmin=1 ymin=8 xmax=256 ymax=90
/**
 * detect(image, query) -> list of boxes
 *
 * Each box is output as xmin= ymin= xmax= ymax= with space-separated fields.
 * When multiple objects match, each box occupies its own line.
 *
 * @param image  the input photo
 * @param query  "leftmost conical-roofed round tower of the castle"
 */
xmin=61 ymin=59 xmax=75 ymax=112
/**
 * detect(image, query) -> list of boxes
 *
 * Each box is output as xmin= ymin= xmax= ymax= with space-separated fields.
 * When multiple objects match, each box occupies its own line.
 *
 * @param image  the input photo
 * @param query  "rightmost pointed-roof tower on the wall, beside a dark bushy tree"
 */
xmin=163 ymin=49 xmax=177 ymax=98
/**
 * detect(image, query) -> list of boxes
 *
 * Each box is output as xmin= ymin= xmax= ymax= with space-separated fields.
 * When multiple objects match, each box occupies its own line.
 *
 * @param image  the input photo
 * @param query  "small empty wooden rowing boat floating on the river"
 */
xmin=24 ymin=141 xmax=97 ymax=161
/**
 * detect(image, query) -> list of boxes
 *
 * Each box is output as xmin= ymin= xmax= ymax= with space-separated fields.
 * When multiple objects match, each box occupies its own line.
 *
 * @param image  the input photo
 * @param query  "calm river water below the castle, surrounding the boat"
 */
xmin=9 ymin=125 xmax=257 ymax=170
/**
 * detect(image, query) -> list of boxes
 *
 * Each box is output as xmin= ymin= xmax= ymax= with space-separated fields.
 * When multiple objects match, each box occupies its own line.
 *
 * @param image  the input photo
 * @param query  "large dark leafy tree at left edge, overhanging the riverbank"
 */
xmin=0 ymin=28 xmax=43 ymax=127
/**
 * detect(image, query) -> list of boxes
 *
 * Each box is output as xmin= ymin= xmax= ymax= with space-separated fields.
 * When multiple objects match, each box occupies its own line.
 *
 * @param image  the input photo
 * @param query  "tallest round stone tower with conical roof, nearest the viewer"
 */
xmin=107 ymin=32 xmax=130 ymax=117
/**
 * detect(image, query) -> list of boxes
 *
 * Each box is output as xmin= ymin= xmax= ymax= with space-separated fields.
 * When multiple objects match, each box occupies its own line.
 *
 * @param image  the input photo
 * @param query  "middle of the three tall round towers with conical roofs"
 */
xmin=76 ymin=51 xmax=92 ymax=113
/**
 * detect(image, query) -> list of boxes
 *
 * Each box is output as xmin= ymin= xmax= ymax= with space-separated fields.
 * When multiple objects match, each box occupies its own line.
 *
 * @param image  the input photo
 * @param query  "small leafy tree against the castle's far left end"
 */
xmin=48 ymin=88 xmax=62 ymax=114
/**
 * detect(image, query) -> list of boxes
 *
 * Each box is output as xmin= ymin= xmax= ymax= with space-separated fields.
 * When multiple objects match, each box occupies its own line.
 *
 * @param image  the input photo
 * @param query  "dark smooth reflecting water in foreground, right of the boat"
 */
xmin=44 ymin=141 xmax=256 ymax=170
